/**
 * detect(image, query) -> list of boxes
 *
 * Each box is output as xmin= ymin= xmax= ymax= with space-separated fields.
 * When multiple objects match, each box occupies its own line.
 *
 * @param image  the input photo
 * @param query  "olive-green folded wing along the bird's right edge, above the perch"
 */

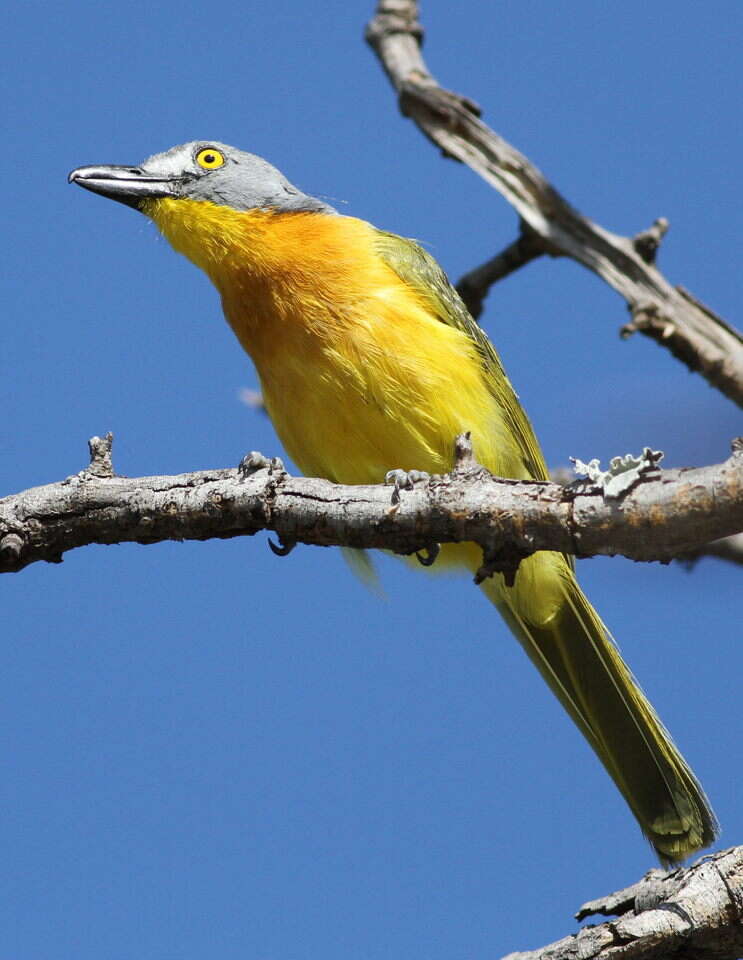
xmin=376 ymin=230 xmax=548 ymax=480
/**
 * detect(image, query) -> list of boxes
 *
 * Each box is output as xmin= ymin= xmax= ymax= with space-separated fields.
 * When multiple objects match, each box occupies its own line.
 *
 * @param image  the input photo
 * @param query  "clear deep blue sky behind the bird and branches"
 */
xmin=0 ymin=0 xmax=743 ymax=960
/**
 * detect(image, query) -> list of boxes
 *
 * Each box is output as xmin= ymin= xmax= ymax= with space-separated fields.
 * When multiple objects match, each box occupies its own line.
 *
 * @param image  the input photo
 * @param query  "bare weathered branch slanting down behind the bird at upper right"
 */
xmin=366 ymin=0 xmax=743 ymax=406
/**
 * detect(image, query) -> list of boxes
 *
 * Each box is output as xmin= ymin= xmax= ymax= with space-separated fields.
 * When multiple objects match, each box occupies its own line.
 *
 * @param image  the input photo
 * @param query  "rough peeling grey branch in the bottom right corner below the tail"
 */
xmin=503 ymin=847 xmax=743 ymax=960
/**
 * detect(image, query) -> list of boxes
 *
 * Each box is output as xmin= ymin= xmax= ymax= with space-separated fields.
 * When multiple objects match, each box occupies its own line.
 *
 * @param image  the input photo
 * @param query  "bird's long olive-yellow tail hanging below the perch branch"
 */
xmin=483 ymin=553 xmax=717 ymax=865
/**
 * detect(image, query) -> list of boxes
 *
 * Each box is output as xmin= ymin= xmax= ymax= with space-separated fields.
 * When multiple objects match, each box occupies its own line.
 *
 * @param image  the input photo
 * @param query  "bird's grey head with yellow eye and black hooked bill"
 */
xmin=68 ymin=140 xmax=336 ymax=213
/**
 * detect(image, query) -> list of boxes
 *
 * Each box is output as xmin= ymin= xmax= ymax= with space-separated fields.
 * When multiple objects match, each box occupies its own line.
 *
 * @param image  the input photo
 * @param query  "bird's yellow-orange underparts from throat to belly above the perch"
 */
xmin=145 ymin=199 xmax=523 ymax=483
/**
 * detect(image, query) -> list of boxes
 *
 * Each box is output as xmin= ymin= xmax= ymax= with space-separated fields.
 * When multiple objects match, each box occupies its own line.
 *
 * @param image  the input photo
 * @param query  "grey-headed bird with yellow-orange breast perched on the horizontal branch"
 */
xmin=68 ymin=140 xmax=718 ymax=866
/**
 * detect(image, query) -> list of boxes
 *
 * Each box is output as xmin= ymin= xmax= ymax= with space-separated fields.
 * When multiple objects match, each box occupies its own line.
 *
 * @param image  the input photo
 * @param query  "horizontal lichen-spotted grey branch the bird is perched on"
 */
xmin=0 ymin=434 xmax=743 ymax=579
